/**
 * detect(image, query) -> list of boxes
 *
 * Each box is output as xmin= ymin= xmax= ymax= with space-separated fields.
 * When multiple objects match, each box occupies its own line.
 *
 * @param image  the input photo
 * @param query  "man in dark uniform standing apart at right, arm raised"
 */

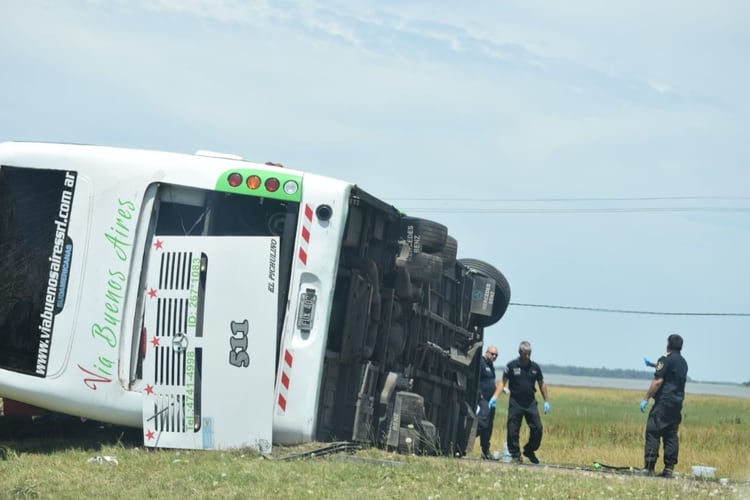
xmin=641 ymin=334 xmax=687 ymax=478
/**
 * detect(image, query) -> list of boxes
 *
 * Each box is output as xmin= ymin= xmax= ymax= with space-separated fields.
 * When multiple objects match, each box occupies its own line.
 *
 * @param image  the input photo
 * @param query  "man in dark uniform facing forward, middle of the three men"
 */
xmin=490 ymin=340 xmax=550 ymax=464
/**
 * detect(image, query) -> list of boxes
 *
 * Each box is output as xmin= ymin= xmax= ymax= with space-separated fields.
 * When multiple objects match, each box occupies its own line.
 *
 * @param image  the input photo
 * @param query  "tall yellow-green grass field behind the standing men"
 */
xmin=475 ymin=387 xmax=750 ymax=480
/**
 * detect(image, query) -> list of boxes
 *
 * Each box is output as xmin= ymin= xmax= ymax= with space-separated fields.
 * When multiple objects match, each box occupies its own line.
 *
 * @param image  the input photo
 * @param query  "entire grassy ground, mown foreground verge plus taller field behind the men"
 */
xmin=0 ymin=387 xmax=750 ymax=499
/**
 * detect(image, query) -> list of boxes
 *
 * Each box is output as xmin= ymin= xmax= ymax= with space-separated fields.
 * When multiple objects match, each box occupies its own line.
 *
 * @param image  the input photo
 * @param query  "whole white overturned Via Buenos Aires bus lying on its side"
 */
xmin=0 ymin=142 xmax=510 ymax=453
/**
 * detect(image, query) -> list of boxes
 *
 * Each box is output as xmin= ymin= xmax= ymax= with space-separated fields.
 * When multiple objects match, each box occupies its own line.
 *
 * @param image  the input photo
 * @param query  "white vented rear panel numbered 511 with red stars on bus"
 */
xmin=142 ymin=236 xmax=279 ymax=452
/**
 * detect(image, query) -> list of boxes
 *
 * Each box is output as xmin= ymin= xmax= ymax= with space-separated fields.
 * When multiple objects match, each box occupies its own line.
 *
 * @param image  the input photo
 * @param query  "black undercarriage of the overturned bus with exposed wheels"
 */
xmin=317 ymin=189 xmax=510 ymax=455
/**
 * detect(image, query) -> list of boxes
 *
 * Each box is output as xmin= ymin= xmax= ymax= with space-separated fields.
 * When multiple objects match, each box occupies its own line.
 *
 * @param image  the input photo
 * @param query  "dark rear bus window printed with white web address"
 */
xmin=0 ymin=165 xmax=76 ymax=377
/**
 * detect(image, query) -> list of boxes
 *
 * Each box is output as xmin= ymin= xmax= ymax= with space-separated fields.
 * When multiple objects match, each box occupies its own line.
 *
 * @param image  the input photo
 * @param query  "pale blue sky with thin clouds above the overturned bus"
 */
xmin=0 ymin=0 xmax=750 ymax=384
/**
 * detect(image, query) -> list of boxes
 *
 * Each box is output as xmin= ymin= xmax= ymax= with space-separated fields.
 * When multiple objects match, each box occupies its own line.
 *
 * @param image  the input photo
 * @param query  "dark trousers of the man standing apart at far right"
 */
xmin=644 ymin=401 xmax=682 ymax=469
